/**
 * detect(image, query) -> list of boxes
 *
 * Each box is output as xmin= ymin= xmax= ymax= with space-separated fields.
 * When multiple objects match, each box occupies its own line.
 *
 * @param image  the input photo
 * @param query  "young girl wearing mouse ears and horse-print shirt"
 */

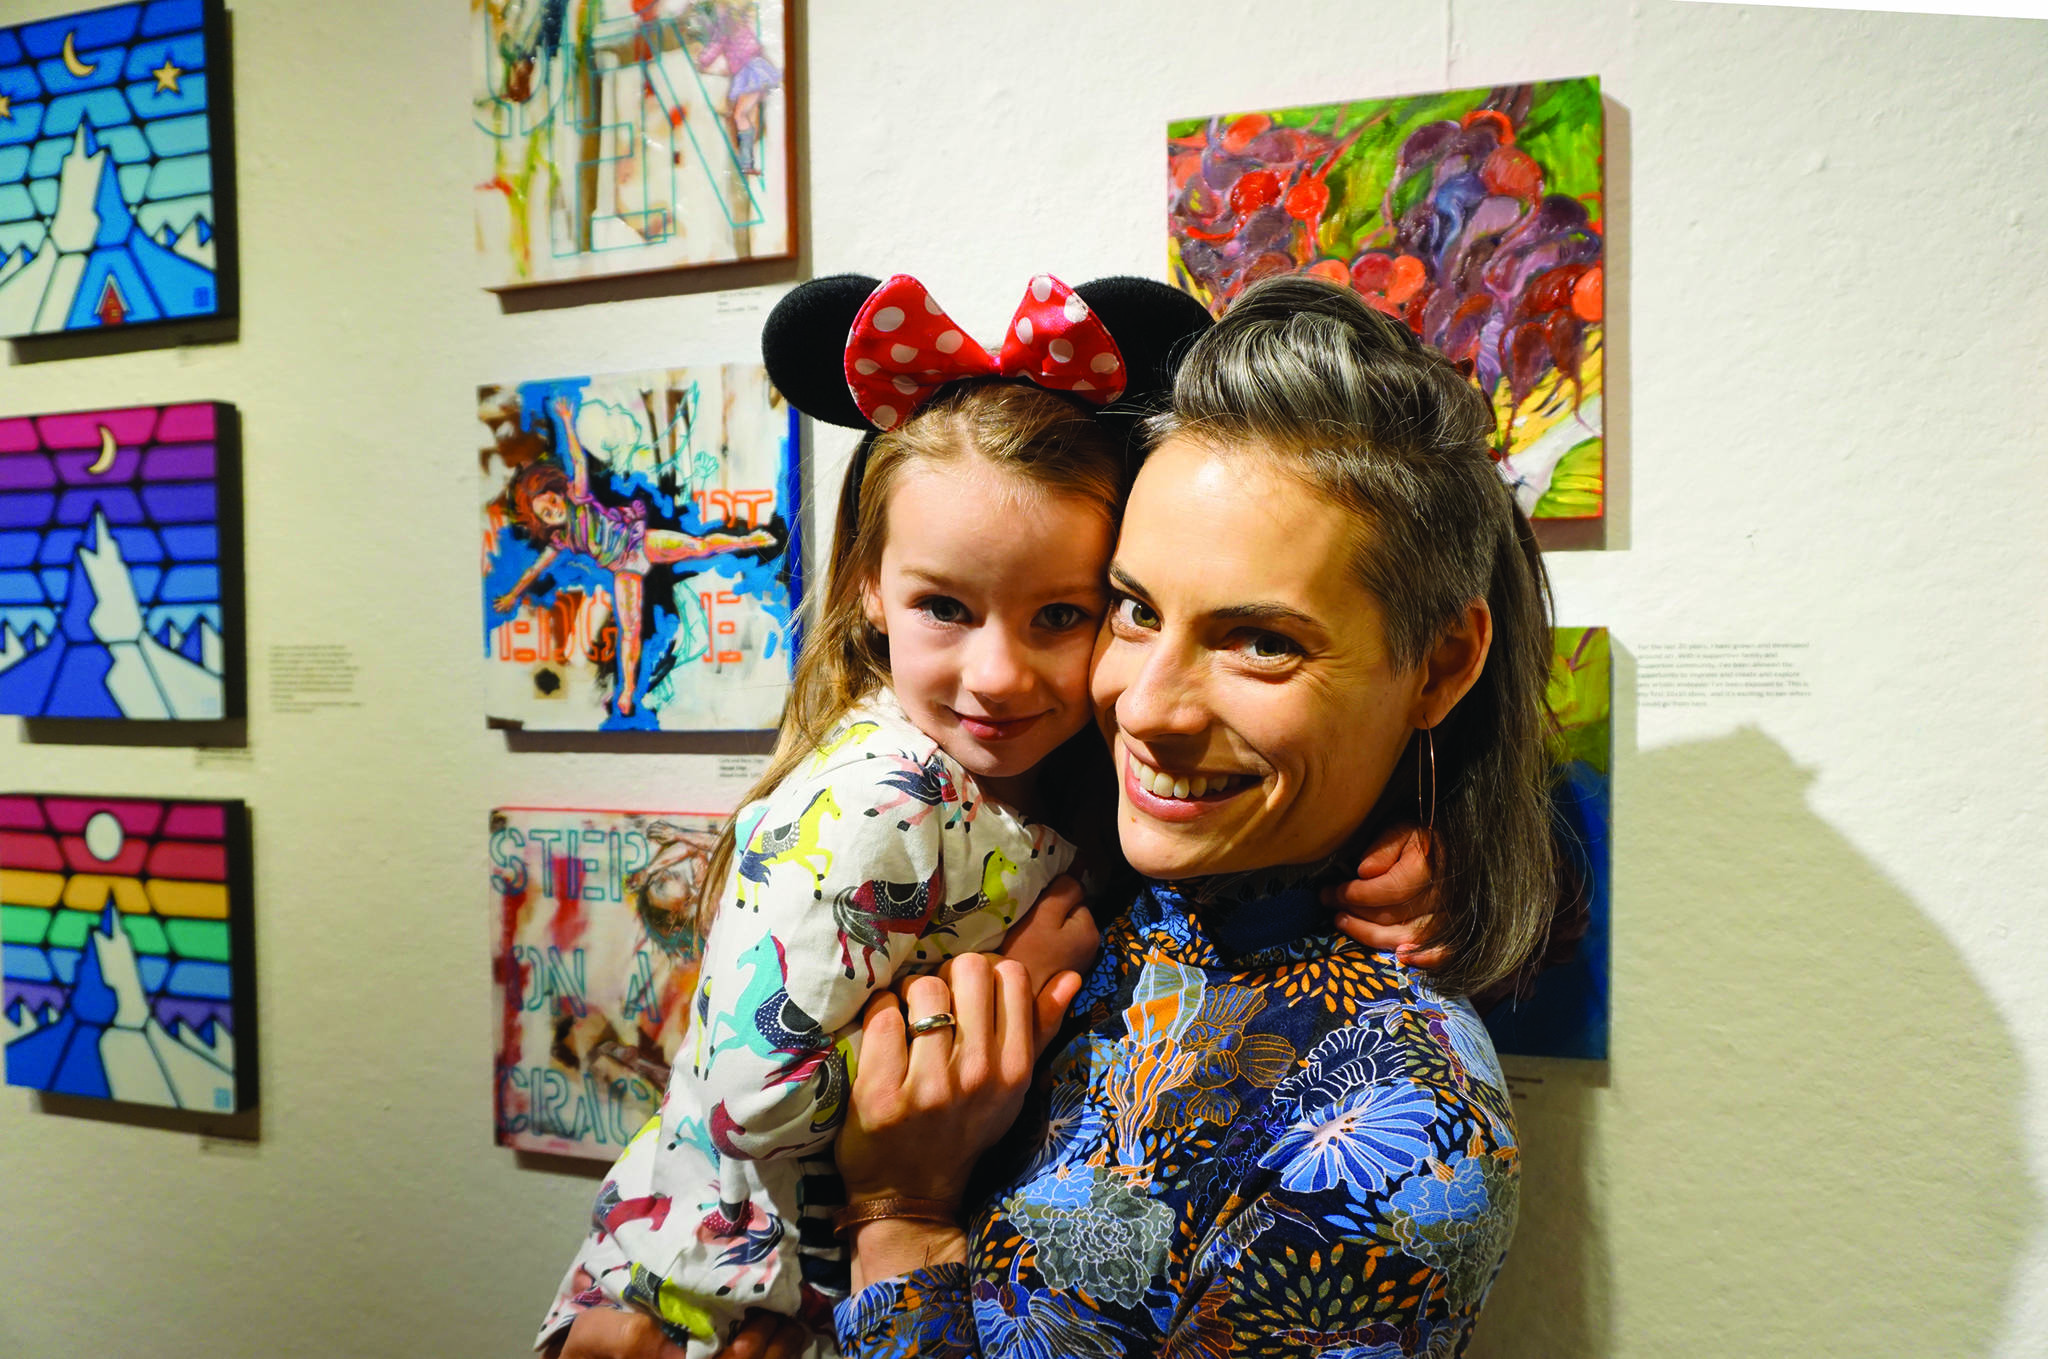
xmin=541 ymin=276 xmax=1208 ymax=1355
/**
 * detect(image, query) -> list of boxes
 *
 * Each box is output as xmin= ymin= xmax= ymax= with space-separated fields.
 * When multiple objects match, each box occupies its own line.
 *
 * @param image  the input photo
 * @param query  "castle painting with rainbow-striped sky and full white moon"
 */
xmin=0 ymin=794 xmax=256 ymax=1113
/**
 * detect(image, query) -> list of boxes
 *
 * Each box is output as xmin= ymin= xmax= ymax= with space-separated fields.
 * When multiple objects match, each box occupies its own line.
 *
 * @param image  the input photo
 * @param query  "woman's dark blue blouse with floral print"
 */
xmin=836 ymin=884 xmax=1520 ymax=1359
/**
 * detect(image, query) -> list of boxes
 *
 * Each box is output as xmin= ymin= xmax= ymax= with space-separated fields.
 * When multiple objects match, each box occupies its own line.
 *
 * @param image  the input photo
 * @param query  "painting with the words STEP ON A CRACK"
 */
xmin=492 ymin=806 xmax=725 ymax=1160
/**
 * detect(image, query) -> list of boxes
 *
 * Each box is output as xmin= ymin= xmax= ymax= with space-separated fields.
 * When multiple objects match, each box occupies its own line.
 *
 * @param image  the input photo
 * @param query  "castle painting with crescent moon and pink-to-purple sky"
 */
xmin=0 ymin=403 xmax=246 ymax=722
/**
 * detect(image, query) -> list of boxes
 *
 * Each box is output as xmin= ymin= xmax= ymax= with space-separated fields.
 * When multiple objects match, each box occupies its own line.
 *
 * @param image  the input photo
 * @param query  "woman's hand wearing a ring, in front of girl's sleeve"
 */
xmin=838 ymin=954 xmax=1081 ymax=1203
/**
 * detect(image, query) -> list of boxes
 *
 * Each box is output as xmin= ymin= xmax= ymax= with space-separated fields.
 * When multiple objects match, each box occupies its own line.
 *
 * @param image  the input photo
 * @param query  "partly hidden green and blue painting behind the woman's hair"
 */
xmin=1487 ymin=628 xmax=1614 ymax=1060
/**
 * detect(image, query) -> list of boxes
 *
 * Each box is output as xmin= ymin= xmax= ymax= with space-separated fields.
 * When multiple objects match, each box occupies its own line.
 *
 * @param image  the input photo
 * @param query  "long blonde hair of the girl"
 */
xmin=696 ymin=381 xmax=1128 ymax=931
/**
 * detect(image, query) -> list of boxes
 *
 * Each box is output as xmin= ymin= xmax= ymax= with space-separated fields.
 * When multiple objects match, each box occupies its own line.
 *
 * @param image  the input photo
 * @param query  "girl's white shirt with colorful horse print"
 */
xmin=539 ymin=692 xmax=1073 ymax=1359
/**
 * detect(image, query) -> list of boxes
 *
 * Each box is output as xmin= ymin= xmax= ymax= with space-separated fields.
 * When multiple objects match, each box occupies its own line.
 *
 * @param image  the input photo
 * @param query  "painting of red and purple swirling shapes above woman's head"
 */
xmin=1167 ymin=78 xmax=1606 ymax=520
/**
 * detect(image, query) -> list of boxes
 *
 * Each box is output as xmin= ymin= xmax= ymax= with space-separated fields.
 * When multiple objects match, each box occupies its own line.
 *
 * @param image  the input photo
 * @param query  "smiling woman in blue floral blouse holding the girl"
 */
xmin=567 ymin=278 xmax=1554 ymax=1359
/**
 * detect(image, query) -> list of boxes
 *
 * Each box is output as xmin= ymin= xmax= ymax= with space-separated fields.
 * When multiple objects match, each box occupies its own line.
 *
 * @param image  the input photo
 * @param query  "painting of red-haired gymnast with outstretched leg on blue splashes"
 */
xmin=477 ymin=364 xmax=803 ymax=731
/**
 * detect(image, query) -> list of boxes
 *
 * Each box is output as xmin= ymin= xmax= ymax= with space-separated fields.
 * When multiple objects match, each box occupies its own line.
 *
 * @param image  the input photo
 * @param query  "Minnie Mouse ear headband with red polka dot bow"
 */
xmin=762 ymin=274 xmax=1212 ymax=434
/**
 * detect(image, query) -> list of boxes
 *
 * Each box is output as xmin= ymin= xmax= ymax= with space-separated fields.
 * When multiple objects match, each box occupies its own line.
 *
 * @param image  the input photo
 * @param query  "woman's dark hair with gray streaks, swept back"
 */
xmin=1147 ymin=276 xmax=1559 ymax=995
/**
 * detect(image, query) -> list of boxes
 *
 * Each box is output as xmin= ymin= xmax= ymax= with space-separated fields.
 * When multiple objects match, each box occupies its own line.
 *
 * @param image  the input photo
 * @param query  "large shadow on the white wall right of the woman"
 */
xmin=1470 ymin=728 xmax=2040 ymax=1359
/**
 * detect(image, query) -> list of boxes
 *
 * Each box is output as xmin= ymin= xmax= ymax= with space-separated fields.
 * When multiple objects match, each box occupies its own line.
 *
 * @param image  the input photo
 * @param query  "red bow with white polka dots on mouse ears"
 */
xmin=846 ymin=274 xmax=1124 ymax=430
